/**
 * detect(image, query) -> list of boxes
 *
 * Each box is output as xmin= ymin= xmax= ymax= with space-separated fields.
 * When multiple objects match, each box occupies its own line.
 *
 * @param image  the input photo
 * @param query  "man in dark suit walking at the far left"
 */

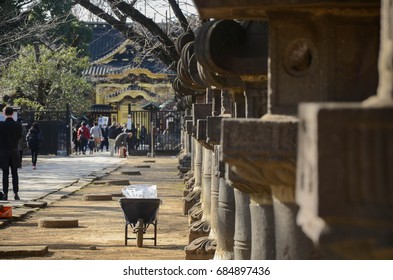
xmin=0 ymin=106 xmax=22 ymax=200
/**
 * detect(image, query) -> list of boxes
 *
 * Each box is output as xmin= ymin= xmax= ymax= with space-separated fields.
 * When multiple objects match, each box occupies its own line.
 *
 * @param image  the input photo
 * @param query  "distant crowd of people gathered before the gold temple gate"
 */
xmin=72 ymin=122 xmax=147 ymax=157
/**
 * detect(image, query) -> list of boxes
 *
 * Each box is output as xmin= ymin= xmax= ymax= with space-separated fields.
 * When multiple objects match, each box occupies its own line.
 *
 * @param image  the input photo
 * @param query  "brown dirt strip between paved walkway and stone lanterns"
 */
xmin=0 ymin=157 xmax=188 ymax=260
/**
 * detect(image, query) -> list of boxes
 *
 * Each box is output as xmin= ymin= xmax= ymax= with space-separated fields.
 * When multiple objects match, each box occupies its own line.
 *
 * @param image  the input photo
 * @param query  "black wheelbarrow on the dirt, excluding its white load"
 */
xmin=119 ymin=197 xmax=161 ymax=247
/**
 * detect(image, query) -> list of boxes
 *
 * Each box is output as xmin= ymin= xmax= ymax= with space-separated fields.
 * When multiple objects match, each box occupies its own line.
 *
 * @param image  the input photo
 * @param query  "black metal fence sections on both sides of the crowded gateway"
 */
xmin=18 ymin=107 xmax=181 ymax=155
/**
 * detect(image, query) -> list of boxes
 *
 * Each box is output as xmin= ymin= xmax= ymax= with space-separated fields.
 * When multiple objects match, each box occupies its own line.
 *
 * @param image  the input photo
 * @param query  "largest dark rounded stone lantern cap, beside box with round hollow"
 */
xmin=194 ymin=20 xmax=268 ymax=76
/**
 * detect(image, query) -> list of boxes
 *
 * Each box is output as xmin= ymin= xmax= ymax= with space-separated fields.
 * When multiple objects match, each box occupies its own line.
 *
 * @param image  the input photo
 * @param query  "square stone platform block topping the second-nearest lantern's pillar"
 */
xmin=221 ymin=115 xmax=298 ymax=189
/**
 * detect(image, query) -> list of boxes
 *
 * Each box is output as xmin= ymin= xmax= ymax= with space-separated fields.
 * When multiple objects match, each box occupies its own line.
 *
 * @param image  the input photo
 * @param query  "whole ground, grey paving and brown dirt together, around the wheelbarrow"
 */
xmin=0 ymin=152 xmax=189 ymax=260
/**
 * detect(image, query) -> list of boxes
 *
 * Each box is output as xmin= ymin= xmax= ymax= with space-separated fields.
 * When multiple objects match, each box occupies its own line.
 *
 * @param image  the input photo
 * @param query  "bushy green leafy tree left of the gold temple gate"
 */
xmin=1 ymin=45 xmax=93 ymax=114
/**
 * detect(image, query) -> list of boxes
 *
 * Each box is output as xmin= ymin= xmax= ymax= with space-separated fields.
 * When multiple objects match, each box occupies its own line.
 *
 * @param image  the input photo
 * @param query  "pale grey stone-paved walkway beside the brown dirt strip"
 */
xmin=0 ymin=152 xmax=125 ymax=222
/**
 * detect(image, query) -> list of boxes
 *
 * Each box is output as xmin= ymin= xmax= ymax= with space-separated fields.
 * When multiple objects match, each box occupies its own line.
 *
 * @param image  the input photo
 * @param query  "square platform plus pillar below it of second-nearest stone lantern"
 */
xmin=222 ymin=115 xmax=313 ymax=259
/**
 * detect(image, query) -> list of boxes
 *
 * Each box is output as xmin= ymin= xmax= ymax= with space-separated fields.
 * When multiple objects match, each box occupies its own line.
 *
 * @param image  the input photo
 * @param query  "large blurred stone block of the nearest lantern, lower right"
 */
xmin=296 ymin=103 xmax=393 ymax=259
